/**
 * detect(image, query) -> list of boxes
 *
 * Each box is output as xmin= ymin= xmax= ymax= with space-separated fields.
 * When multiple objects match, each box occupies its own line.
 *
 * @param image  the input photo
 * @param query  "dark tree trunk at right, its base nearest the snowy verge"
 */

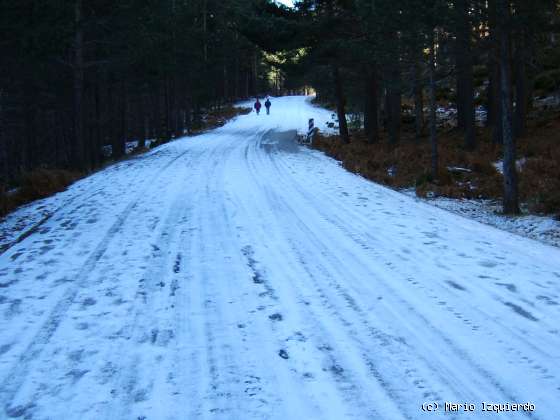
xmin=498 ymin=0 xmax=519 ymax=214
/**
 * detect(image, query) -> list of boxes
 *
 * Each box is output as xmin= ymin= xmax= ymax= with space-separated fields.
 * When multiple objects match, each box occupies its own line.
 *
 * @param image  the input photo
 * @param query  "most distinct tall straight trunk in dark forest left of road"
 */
xmin=72 ymin=0 xmax=86 ymax=170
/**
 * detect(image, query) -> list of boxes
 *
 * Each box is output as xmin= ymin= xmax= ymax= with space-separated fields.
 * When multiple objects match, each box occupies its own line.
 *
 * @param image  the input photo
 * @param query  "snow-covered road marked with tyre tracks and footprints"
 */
xmin=0 ymin=97 xmax=560 ymax=420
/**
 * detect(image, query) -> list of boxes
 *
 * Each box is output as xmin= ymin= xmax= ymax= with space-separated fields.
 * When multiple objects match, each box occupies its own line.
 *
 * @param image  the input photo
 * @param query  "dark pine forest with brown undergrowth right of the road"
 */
xmin=256 ymin=0 xmax=560 ymax=215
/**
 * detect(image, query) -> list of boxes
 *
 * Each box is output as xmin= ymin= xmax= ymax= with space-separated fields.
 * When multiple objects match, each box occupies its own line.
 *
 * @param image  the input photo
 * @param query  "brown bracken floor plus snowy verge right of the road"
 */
xmin=314 ymin=110 xmax=560 ymax=246
